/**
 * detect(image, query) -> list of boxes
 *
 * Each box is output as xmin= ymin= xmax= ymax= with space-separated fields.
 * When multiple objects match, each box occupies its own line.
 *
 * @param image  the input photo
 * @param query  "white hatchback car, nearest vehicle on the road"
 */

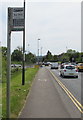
xmin=60 ymin=65 xmax=78 ymax=78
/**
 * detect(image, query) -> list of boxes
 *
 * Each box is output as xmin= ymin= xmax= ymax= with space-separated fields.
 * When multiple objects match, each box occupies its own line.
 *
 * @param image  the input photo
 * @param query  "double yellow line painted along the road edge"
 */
xmin=49 ymin=70 xmax=83 ymax=114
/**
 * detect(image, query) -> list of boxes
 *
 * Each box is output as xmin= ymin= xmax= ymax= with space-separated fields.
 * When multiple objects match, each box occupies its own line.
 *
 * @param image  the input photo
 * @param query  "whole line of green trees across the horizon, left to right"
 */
xmin=2 ymin=46 xmax=83 ymax=63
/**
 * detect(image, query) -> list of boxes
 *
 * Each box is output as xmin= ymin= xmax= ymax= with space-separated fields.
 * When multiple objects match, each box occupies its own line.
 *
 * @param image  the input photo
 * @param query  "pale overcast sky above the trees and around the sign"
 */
xmin=0 ymin=0 xmax=81 ymax=55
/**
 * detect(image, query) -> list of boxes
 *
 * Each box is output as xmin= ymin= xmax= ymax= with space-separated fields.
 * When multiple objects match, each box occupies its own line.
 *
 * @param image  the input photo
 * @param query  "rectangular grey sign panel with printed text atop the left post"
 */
xmin=10 ymin=7 xmax=24 ymax=31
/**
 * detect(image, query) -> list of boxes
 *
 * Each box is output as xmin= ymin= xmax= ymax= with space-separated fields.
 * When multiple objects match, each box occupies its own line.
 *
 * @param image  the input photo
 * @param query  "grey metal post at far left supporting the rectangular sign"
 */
xmin=7 ymin=8 xmax=11 ymax=118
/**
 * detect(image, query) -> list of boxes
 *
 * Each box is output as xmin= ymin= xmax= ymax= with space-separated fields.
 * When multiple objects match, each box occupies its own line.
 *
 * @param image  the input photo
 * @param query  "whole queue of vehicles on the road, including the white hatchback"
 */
xmin=42 ymin=62 xmax=83 ymax=78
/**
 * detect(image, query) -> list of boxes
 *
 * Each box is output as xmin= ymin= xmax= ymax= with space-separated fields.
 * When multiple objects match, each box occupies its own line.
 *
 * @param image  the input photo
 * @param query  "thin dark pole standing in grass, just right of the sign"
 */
xmin=22 ymin=0 xmax=25 ymax=85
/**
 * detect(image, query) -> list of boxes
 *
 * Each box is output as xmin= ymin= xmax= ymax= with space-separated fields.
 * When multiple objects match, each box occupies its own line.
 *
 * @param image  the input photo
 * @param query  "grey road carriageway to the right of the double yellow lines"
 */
xmin=47 ymin=67 xmax=83 ymax=103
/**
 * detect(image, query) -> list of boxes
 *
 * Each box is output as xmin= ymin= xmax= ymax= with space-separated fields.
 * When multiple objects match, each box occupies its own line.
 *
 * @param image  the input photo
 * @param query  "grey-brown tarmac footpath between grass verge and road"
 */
xmin=18 ymin=68 xmax=71 ymax=118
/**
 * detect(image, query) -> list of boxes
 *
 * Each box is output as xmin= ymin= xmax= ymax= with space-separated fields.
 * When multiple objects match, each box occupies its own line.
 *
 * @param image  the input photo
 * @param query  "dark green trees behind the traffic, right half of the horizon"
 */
xmin=43 ymin=49 xmax=83 ymax=62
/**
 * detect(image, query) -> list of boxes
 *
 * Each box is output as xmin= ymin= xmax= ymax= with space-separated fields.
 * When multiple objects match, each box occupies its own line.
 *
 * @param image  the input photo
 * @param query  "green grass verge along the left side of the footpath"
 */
xmin=2 ymin=68 xmax=38 ymax=118
